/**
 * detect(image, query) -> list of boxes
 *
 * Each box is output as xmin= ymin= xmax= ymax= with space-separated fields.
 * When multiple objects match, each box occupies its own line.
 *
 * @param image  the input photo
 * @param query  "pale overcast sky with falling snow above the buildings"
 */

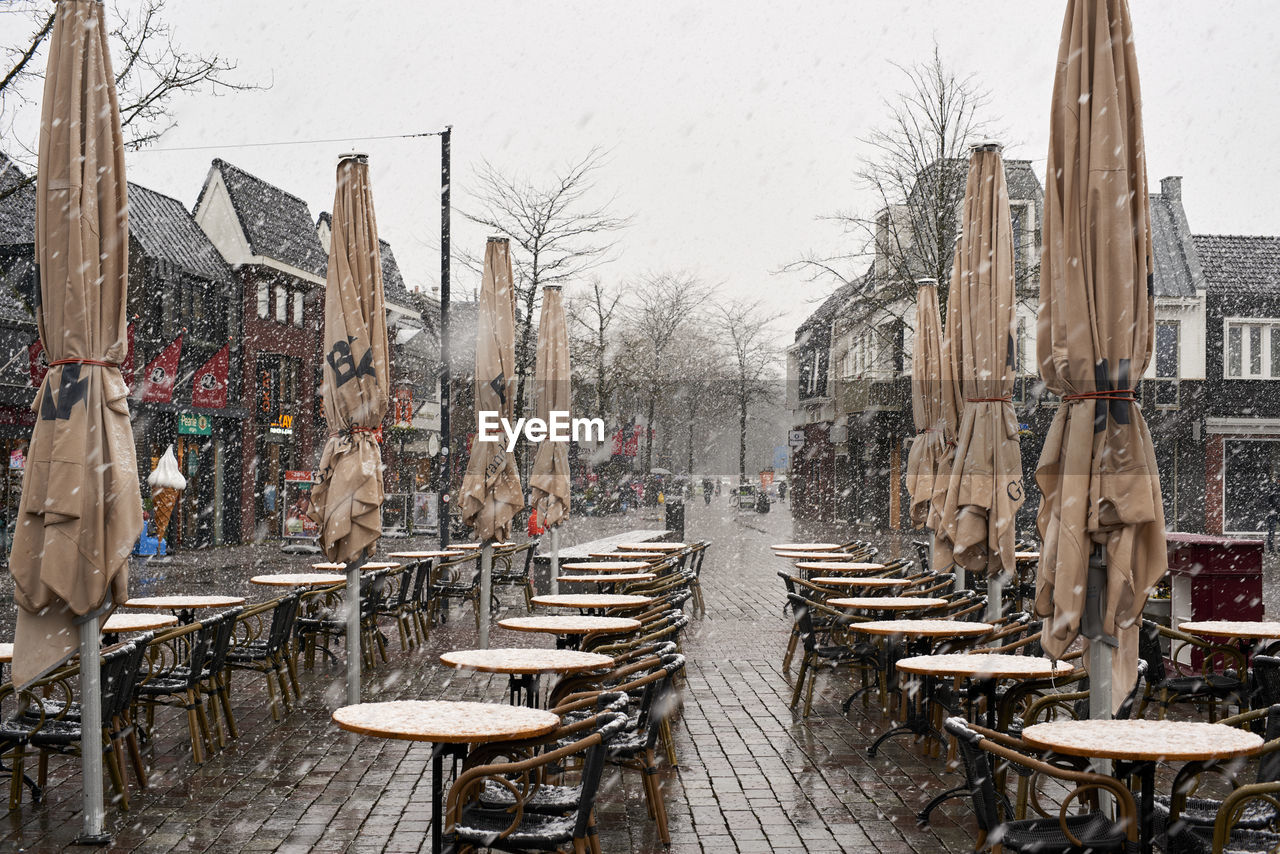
xmin=0 ymin=0 xmax=1280 ymax=339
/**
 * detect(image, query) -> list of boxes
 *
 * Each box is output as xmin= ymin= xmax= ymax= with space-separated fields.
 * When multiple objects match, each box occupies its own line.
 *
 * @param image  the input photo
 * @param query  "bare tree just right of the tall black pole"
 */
xmin=462 ymin=149 xmax=631 ymax=440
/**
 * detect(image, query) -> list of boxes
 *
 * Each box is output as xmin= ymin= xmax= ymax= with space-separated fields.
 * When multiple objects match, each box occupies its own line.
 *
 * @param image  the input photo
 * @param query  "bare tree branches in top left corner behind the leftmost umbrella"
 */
xmin=0 ymin=0 xmax=265 ymax=201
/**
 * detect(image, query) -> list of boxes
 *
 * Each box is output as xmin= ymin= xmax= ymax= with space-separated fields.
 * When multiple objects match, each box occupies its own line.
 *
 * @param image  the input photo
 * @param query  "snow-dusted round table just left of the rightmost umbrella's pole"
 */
xmin=897 ymin=653 xmax=1075 ymax=825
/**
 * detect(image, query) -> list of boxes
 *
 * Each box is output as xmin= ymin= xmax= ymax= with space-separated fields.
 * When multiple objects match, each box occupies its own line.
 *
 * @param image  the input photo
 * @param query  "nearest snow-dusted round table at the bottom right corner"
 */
xmin=1023 ymin=720 xmax=1262 ymax=854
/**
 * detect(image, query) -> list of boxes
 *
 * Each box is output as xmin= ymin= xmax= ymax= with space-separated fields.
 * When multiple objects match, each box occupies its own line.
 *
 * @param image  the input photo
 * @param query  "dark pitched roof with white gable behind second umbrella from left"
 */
xmin=196 ymin=157 xmax=329 ymax=277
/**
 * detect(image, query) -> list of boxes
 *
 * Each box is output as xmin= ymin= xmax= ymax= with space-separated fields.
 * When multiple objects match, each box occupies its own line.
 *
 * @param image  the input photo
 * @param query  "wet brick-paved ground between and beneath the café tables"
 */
xmin=0 ymin=501 xmax=973 ymax=854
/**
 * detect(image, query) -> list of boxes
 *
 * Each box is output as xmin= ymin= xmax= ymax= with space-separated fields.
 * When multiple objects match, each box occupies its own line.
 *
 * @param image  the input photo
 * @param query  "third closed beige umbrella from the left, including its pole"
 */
xmin=458 ymin=237 xmax=525 ymax=649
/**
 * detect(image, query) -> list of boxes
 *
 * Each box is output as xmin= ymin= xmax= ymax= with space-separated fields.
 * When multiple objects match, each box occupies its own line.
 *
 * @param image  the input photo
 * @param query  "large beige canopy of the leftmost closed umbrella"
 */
xmin=9 ymin=0 xmax=142 ymax=685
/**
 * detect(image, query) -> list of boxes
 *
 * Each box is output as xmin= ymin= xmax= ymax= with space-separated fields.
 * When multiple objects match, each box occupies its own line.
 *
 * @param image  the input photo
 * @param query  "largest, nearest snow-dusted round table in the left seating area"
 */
xmin=333 ymin=700 xmax=559 ymax=854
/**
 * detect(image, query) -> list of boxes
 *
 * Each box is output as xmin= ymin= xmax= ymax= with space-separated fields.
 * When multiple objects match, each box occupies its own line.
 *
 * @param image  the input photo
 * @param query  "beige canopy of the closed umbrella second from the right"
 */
xmin=942 ymin=145 xmax=1023 ymax=583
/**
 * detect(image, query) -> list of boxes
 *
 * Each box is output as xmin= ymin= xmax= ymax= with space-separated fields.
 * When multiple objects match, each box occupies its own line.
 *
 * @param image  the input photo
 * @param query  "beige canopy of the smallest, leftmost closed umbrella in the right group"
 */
xmin=906 ymin=279 xmax=947 ymax=528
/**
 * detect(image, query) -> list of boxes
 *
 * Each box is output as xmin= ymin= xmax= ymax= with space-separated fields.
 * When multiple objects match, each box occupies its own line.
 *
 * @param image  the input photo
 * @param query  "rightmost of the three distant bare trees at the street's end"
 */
xmin=710 ymin=302 xmax=778 ymax=483
